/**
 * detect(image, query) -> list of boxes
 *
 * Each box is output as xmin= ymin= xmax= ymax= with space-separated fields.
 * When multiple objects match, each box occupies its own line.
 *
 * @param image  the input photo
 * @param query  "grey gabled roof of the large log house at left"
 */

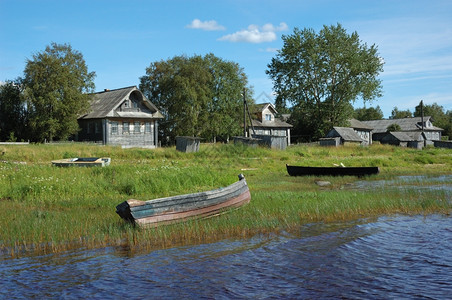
xmin=79 ymin=86 xmax=163 ymax=119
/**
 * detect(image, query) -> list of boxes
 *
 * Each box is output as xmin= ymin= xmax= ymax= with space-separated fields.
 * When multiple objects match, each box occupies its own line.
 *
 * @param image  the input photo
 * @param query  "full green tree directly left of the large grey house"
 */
xmin=23 ymin=43 xmax=95 ymax=142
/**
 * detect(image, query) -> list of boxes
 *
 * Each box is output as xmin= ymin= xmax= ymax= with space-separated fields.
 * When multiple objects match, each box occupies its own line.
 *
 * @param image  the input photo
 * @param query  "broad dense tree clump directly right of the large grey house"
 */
xmin=140 ymin=54 xmax=247 ymax=141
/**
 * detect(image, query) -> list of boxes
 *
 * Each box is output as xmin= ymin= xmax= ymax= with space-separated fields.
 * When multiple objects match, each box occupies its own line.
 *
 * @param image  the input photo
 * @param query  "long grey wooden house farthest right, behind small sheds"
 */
xmin=361 ymin=116 xmax=443 ymax=145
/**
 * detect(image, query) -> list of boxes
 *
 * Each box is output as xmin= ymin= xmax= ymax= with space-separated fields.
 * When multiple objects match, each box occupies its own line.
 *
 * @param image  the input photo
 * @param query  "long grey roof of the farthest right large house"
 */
xmin=362 ymin=116 xmax=443 ymax=133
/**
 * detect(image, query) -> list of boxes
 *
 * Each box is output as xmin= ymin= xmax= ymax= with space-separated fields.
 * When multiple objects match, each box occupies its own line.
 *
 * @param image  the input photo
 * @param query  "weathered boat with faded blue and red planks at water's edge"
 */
xmin=116 ymin=174 xmax=251 ymax=227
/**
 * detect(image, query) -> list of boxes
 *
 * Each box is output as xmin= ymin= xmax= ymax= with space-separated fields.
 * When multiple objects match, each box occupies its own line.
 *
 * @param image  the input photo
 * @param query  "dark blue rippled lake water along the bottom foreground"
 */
xmin=0 ymin=215 xmax=452 ymax=299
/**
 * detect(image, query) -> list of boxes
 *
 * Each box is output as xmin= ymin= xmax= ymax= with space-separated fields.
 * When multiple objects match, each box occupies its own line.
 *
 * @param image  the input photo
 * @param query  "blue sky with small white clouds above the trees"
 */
xmin=0 ymin=0 xmax=452 ymax=117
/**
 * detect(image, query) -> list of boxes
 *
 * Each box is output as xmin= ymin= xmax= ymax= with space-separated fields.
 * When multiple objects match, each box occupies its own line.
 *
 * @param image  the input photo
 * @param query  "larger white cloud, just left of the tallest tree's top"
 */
xmin=218 ymin=22 xmax=288 ymax=44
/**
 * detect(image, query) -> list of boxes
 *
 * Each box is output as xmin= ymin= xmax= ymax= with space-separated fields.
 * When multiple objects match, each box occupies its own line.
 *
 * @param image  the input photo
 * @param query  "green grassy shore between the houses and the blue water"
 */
xmin=0 ymin=144 xmax=452 ymax=256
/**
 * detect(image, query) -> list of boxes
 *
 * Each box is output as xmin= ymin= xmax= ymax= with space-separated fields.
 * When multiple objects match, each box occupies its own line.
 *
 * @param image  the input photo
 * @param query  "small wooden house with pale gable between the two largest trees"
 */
xmin=248 ymin=103 xmax=293 ymax=149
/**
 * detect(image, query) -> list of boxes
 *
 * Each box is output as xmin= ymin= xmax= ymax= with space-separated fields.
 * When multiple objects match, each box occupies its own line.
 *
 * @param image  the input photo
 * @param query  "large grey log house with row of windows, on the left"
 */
xmin=75 ymin=86 xmax=163 ymax=148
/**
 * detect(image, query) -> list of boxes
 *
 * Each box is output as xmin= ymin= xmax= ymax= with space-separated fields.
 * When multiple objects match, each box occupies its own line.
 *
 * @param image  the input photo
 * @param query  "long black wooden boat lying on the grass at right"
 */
xmin=286 ymin=165 xmax=380 ymax=177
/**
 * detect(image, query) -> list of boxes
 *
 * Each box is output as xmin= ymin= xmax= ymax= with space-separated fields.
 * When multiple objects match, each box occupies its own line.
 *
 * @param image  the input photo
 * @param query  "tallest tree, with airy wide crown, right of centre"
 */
xmin=266 ymin=24 xmax=383 ymax=138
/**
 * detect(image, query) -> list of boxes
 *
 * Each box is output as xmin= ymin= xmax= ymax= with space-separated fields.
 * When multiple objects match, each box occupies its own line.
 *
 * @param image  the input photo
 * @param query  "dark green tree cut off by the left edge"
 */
xmin=0 ymin=80 xmax=27 ymax=141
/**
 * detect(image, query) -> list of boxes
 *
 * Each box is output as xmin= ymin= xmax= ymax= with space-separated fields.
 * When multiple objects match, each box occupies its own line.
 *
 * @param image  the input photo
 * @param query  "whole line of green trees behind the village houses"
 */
xmin=0 ymin=24 xmax=452 ymax=142
